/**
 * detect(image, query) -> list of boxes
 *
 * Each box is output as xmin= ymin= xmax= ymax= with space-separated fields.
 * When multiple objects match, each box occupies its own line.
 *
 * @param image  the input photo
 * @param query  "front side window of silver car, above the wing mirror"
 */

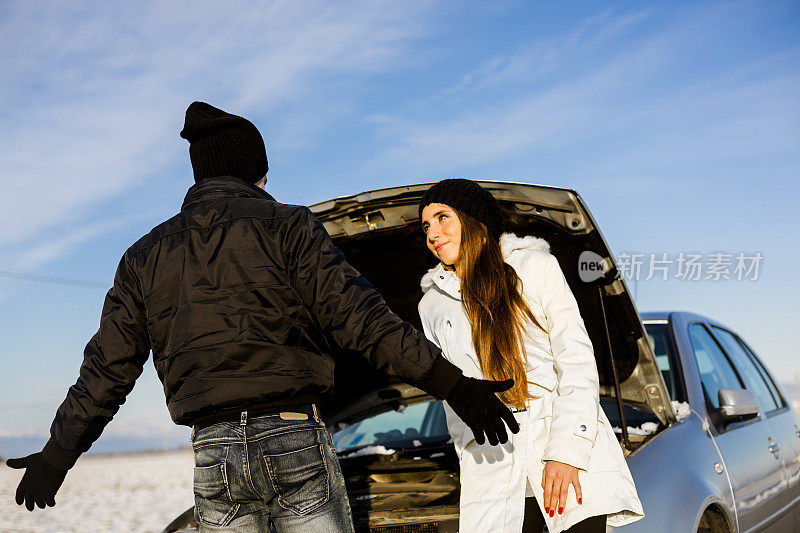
xmin=689 ymin=324 xmax=743 ymax=409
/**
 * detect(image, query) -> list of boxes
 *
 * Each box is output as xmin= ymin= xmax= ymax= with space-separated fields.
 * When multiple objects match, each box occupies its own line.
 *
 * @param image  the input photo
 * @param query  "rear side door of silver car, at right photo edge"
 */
xmin=712 ymin=327 xmax=800 ymax=526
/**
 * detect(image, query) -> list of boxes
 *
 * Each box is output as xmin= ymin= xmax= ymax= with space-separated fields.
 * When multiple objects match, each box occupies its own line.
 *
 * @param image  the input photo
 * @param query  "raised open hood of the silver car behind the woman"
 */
xmin=311 ymin=181 xmax=675 ymax=425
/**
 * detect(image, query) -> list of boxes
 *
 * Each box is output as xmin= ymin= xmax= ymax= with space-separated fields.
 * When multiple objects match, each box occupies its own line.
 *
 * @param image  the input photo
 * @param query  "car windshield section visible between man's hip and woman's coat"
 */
xmin=333 ymin=401 xmax=450 ymax=452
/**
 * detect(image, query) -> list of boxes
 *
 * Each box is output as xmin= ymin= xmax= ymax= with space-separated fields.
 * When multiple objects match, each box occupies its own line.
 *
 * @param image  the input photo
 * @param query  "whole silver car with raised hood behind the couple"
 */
xmin=165 ymin=181 xmax=800 ymax=533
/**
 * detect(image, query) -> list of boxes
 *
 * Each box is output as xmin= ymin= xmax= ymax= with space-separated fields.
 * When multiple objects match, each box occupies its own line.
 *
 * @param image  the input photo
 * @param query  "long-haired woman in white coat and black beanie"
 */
xmin=419 ymin=180 xmax=644 ymax=533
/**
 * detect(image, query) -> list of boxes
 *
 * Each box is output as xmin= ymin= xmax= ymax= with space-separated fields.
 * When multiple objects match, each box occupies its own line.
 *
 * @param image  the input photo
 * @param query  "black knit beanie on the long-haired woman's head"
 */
xmin=419 ymin=179 xmax=504 ymax=239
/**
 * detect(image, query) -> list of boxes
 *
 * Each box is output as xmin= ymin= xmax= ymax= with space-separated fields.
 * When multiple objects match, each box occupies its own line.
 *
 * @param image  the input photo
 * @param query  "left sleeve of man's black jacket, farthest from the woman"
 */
xmin=42 ymin=254 xmax=150 ymax=469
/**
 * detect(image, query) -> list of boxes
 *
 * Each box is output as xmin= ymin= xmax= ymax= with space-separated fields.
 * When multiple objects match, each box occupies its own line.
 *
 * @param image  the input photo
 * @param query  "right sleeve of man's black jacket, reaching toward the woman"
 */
xmin=284 ymin=208 xmax=461 ymax=398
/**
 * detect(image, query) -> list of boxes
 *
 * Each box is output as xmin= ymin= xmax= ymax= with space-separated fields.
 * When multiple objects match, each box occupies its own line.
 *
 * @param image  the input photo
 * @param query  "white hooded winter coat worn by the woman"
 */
xmin=419 ymin=233 xmax=644 ymax=533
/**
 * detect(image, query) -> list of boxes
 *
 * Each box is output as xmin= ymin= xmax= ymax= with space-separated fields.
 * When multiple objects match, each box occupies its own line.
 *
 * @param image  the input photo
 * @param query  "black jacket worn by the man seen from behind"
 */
xmin=45 ymin=177 xmax=461 ymax=467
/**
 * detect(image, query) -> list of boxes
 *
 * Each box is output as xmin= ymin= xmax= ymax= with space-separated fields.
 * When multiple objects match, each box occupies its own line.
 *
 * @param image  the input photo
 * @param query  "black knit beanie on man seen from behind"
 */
xmin=181 ymin=102 xmax=269 ymax=183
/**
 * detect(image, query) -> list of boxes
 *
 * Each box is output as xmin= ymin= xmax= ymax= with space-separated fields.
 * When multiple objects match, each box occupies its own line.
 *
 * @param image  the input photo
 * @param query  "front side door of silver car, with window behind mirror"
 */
xmin=689 ymin=323 xmax=786 ymax=531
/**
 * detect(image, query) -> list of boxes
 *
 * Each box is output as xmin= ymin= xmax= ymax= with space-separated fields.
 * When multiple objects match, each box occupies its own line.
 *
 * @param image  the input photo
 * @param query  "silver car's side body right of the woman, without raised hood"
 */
xmin=624 ymin=312 xmax=800 ymax=532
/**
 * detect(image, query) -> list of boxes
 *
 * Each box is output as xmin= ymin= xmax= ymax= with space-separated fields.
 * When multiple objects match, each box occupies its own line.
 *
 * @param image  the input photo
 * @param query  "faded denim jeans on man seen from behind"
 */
xmin=192 ymin=412 xmax=353 ymax=533
